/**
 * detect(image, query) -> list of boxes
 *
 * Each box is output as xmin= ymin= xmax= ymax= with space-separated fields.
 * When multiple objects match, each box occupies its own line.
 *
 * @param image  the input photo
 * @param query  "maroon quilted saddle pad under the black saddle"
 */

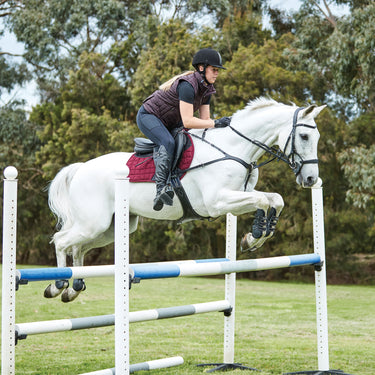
xmin=126 ymin=134 xmax=194 ymax=182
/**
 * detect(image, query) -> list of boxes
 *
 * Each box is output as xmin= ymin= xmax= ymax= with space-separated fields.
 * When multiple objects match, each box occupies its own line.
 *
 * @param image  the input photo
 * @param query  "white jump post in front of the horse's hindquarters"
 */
xmin=115 ymin=166 xmax=130 ymax=375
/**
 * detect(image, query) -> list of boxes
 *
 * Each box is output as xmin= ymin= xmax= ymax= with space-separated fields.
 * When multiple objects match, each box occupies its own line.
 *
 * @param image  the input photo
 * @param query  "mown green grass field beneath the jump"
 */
xmin=1 ymin=267 xmax=375 ymax=375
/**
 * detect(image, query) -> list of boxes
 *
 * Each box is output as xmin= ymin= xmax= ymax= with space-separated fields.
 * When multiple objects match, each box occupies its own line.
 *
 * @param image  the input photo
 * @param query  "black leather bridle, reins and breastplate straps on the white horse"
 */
xmin=180 ymin=107 xmax=319 ymax=185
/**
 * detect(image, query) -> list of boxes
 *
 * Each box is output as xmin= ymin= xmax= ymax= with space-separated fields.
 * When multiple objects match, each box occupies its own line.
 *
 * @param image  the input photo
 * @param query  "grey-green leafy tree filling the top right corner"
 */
xmin=290 ymin=1 xmax=375 ymax=116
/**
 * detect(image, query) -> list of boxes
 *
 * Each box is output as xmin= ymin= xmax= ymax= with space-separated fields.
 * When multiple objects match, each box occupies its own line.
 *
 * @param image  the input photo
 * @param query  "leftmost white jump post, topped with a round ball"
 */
xmin=1 ymin=167 xmax=18 ymax=375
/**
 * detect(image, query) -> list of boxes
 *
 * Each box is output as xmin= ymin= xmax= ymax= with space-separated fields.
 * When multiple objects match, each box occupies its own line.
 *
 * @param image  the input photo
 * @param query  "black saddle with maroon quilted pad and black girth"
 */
xmin=126 ymin=128 xmax=206 ymax=223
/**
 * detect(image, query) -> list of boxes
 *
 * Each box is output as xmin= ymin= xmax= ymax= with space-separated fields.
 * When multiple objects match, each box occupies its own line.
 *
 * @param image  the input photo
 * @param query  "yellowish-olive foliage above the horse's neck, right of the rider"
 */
xmin=217 ymin=34 xmax=313 ymax=114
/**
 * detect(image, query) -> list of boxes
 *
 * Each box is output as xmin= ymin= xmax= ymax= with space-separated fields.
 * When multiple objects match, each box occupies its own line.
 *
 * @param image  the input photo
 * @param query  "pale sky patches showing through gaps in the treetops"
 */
xmin=0 ymin=0 xmax=345 ymax=110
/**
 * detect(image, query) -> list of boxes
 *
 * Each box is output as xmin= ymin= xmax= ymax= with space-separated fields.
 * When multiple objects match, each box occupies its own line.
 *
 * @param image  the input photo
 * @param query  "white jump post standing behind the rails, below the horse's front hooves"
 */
xmin=224 ymin=213 xmax=237 ymax=364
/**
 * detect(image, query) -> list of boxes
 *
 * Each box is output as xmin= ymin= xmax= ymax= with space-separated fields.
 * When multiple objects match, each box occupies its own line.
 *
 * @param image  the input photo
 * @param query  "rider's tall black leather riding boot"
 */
xmin=153 ymin=146 xmax=174 ymax=211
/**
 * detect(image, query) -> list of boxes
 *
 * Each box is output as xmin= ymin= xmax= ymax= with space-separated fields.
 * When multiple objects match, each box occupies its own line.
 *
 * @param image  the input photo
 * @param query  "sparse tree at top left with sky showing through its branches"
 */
xmin=7 ymin=0 xmax=156 ymax=99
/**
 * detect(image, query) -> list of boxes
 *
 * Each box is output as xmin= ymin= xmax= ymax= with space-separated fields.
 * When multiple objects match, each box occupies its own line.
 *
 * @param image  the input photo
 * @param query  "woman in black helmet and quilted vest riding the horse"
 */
xmin=137 ymin=48 xmax=230 ymax=211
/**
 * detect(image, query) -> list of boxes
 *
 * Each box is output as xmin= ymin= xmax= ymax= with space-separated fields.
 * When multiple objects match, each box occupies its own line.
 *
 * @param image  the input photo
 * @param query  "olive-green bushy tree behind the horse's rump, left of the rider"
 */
xmin=30 ymin=53 xmax=135 ymax=179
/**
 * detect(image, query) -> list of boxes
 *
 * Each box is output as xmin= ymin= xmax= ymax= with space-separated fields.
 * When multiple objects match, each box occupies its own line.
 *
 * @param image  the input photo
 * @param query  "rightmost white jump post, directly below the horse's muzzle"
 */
xmin=311 ymin=178 xmax=329 ymax=371
